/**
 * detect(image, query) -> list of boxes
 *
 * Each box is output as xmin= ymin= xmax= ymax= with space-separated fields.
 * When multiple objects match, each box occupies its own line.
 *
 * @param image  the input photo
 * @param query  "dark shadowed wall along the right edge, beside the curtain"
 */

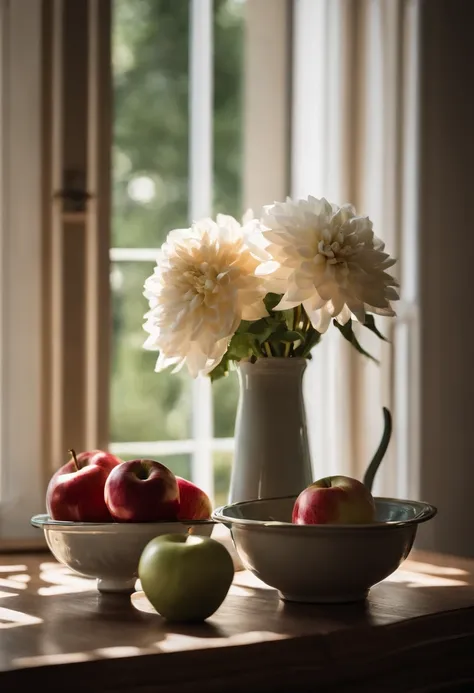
xmin=418 ymin=0 xmax=474 ymax=556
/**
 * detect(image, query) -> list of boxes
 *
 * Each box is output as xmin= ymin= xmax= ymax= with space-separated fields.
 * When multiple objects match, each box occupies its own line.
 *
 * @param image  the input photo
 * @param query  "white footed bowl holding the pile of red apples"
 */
xmin=31 ymin=515 xmax=215 ymax=592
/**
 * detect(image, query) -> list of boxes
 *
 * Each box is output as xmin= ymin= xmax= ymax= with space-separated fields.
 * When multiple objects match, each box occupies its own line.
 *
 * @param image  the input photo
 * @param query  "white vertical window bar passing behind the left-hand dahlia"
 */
xmin=189 ymin=0 xmax=214 ymax=497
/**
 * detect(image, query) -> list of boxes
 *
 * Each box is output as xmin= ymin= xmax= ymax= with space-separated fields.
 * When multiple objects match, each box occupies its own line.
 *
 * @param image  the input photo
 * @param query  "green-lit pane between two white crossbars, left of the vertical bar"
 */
xmin=110 ymin=262 xmax=190 ymax=442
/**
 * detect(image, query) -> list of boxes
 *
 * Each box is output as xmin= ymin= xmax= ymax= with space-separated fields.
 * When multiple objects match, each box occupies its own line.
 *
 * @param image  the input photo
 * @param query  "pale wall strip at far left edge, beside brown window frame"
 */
xmin=0 ymin=0 xmax=44 ymax=541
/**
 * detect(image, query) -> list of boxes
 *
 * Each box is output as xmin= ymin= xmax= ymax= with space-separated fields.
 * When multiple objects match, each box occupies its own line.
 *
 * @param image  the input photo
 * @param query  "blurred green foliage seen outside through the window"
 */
xmin=110 ymin=0 xmax=244 ymax=504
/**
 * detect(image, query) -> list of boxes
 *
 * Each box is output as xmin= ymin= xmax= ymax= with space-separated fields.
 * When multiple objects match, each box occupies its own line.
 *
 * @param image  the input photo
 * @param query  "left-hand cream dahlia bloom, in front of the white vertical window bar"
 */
xmin=144 ymin=214 xmax=268 ymax=377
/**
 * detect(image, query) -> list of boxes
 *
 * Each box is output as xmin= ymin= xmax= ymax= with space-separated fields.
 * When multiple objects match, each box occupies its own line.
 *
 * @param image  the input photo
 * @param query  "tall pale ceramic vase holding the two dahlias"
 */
xmin=229 ymin=358 xmax=313 ymax=503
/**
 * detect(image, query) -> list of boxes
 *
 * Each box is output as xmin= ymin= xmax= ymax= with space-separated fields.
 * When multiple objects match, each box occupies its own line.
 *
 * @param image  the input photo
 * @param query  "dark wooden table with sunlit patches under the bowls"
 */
xmin=0 ymin=553 xmax=474 ymax=693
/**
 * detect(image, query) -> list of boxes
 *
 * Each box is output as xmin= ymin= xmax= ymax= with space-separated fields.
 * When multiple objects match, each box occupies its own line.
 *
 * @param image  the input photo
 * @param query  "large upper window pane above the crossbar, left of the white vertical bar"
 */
xmin=112 ymin=0 xmax=189 ymax=248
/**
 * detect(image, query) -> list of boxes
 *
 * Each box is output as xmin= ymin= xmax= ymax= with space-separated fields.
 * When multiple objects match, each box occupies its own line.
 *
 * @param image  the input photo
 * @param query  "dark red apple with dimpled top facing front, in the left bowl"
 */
xmin=104 ymin=460 xmax=179 ymax=522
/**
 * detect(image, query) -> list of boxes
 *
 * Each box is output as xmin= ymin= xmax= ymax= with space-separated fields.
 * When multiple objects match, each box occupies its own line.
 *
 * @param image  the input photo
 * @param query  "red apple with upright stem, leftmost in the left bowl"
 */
xmin=46 ymin=450 xmax=121 ymax=522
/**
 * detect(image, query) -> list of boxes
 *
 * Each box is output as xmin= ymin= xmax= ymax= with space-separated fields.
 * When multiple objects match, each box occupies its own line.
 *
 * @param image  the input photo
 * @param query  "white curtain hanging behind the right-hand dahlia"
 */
xmin=291 ymin=0 xmax=419 ymax=498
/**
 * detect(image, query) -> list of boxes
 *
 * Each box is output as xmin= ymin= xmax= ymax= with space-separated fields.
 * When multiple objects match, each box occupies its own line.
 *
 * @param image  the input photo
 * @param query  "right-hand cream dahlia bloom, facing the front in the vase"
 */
xmin=262 ymin=197 xmax=399 ymax=332
